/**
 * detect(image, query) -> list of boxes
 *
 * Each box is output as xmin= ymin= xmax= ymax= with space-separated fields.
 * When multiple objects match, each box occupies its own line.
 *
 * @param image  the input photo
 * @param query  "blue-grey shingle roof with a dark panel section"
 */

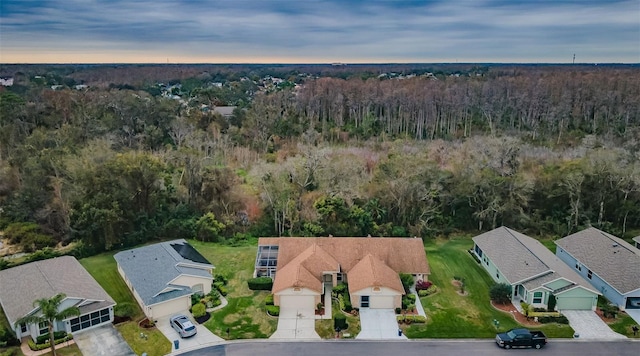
xmin=113 ymin=239 xmax=214 ymax=305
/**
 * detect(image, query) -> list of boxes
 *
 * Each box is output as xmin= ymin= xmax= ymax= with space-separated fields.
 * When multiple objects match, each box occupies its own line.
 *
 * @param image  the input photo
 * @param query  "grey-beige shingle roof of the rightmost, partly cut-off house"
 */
xmin=556 ymin=227 xmax=640 ymax=294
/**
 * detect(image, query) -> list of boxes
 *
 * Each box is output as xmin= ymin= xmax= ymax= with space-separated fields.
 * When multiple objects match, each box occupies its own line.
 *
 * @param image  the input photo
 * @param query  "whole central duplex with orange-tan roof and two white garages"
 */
xmin=255 ymin=237 xmax=429 ymax=309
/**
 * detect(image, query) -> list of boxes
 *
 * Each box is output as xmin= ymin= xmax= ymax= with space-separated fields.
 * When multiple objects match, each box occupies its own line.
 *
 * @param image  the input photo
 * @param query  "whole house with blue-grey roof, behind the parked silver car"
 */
xmin=113 ymin=239 xmax=214 ymax=320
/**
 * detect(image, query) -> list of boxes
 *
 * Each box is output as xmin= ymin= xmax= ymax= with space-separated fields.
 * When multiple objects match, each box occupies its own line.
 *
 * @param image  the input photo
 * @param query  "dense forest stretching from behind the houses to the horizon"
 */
xmin=0 ymin=65 xmax=640 ymax=255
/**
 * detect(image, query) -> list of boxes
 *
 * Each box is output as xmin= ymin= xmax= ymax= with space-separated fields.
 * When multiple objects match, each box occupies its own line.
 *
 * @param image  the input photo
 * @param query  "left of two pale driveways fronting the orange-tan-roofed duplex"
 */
xmin=269 ymin=306 xmax=320 ymax=340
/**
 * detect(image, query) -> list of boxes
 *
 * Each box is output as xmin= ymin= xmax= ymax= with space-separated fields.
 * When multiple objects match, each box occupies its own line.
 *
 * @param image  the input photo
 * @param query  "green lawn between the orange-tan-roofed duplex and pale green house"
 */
xmin=405 ymin=238 xmax=573 ymax=338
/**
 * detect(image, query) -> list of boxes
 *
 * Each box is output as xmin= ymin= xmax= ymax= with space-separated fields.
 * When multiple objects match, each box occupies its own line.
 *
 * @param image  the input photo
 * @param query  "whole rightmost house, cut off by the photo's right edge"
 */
xmin=556 ymin=227 xmax=640 ymax=310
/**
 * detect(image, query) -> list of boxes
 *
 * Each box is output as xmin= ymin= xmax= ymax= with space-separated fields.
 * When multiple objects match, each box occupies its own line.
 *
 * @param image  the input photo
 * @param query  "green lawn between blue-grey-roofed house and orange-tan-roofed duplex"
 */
xmin=189 ymin=240 xmax=278 ymax=340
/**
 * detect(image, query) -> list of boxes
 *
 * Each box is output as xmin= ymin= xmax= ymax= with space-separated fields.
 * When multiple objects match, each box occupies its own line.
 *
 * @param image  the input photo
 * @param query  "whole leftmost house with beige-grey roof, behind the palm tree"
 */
xmin=0 ymin=256 xmax=116 ymax=341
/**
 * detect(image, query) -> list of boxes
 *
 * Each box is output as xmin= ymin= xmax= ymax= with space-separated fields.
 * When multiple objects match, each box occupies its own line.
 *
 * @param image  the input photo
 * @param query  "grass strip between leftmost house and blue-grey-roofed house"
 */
xmin=80 ymin=251 xmax=171 ymax=356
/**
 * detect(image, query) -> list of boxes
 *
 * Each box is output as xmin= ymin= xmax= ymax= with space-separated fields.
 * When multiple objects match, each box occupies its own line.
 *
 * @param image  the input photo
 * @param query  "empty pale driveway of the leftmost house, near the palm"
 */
xmin=73 ymin=324 xmax=135 ymax=356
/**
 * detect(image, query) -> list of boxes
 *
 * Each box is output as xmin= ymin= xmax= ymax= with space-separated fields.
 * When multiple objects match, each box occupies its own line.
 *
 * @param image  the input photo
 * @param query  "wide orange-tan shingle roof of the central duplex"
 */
xmin=258 ymin=237 xmax=429 ymax=293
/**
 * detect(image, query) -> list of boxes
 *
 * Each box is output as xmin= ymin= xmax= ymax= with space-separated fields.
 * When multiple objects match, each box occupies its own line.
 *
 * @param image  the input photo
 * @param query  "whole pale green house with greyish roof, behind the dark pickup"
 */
xmin=473 ymin=227 xmax=600 ymax=311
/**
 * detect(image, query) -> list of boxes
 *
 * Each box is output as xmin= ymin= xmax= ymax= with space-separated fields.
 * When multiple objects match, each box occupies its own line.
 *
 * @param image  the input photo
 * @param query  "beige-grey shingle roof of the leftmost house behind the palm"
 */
xmin=0 ymin=256 xmax=115 ymax=325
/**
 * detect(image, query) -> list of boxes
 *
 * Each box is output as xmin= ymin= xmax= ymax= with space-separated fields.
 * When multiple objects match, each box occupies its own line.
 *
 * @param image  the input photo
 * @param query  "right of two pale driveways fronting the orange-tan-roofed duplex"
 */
xmin=356 ymin=308 xmax=407 ymax=340
